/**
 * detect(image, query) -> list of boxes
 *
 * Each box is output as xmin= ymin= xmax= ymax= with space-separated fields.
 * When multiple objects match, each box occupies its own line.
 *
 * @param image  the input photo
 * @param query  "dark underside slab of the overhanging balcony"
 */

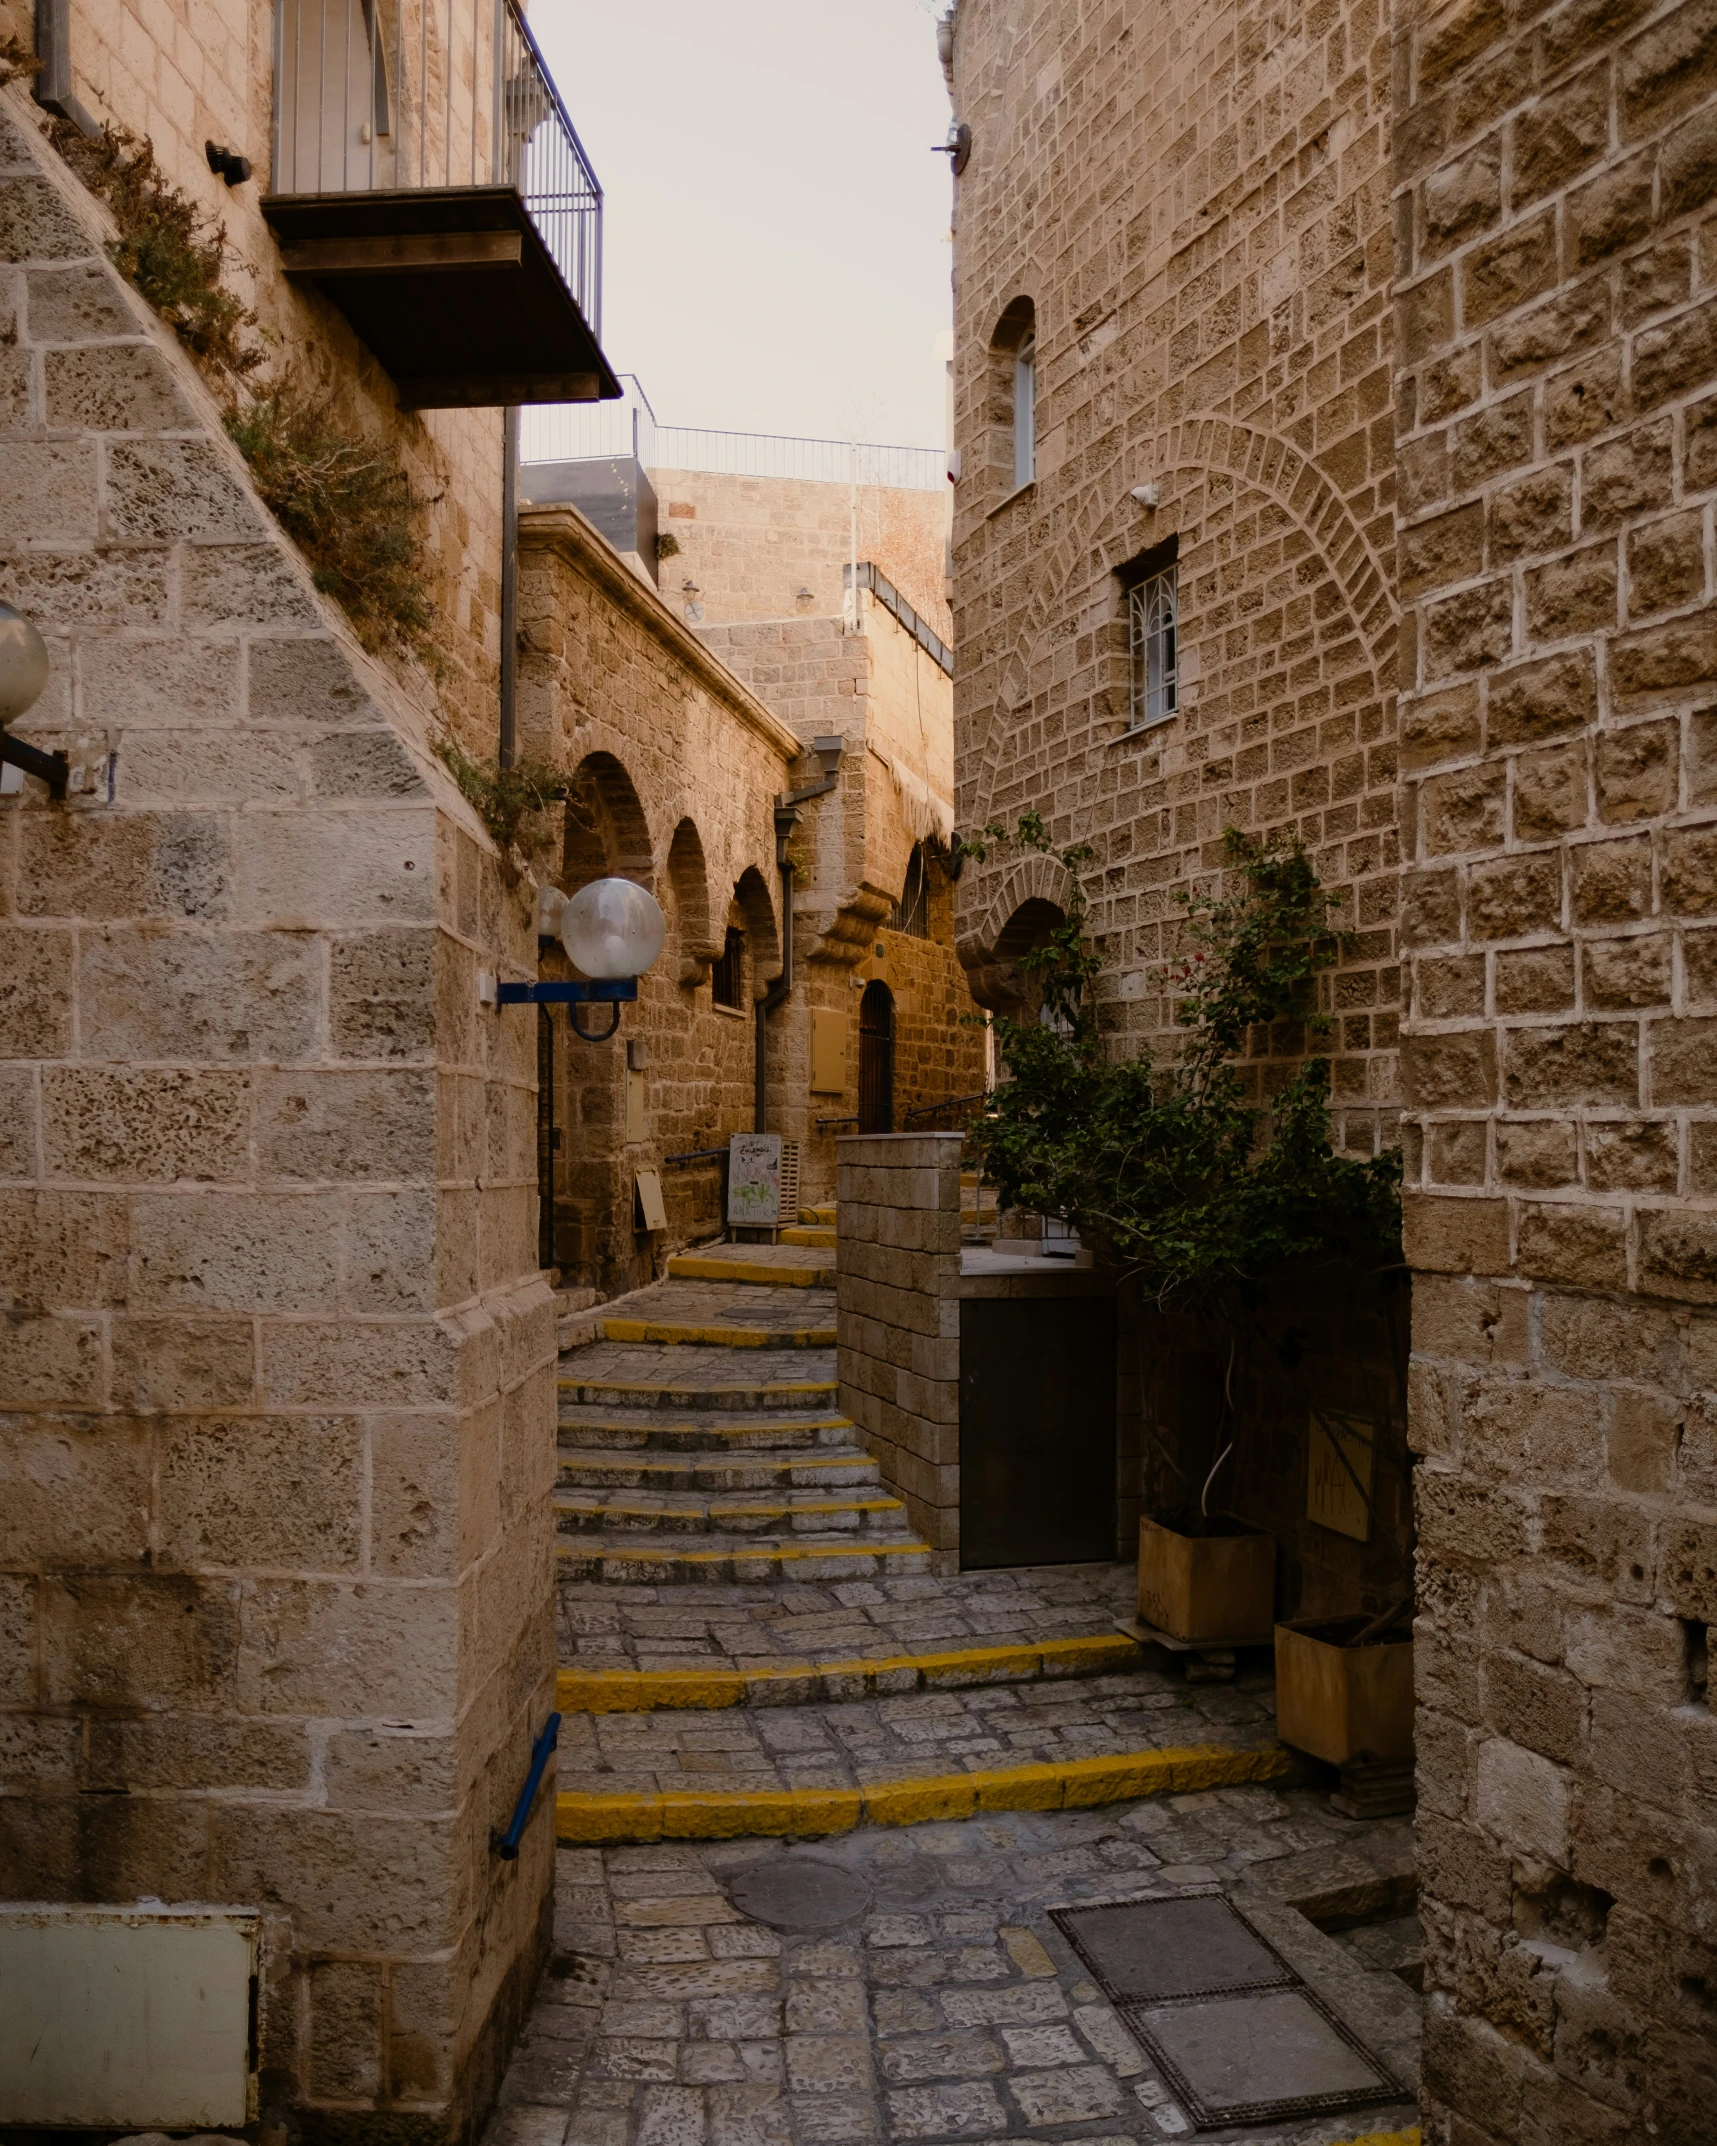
xmin=262 ymin=187 xmax=620 ymax=410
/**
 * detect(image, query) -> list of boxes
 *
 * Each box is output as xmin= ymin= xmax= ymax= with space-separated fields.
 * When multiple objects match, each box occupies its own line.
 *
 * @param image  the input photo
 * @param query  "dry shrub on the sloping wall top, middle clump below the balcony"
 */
xmin=225 ymin=367 xmax=440 ymax=670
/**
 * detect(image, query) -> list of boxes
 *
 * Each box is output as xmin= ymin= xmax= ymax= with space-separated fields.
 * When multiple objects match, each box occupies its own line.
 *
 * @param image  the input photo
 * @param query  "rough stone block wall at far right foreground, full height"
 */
xmin=1395 ymin=4 xmax=1717 ymax=2146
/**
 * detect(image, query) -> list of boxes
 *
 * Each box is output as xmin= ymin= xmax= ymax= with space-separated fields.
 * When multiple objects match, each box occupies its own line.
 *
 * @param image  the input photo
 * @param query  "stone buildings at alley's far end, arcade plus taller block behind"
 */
xmin=519 ymin=442 xmax=985 ymax=1294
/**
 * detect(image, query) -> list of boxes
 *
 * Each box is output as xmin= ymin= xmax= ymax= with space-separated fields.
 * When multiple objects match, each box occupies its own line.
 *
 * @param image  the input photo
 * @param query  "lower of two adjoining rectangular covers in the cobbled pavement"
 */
xmin=1125 ymin=1989 xmax=1402 ymax=2127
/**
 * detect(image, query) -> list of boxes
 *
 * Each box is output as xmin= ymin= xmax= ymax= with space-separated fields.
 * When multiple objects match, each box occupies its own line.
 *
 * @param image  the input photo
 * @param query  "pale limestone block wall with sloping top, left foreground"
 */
xmin=0 ymin=88 xmax=554 ymax=2140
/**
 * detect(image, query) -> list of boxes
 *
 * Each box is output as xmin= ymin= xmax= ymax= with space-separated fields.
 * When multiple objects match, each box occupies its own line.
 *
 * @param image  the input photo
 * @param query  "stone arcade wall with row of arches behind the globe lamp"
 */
xmin=517 ymin=506 xmax=807 ymax=1292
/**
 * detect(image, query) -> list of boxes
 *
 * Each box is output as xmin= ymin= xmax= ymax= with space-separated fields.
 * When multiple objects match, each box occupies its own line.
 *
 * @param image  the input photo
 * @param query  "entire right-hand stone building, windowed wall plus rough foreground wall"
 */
xmin=944 ymin=0 xmax=1717 ymax=2146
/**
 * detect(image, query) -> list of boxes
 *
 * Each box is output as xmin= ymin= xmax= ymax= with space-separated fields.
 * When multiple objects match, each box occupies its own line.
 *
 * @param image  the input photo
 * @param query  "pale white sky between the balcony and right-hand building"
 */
xmin=530 ymin=0 xmax=951 ymax=446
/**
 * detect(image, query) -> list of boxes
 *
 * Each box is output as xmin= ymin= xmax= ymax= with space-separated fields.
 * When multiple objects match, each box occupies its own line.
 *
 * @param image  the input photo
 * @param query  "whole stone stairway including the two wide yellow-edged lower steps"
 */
xmin=543 ymin=1208 xmax=1290 ymax=1843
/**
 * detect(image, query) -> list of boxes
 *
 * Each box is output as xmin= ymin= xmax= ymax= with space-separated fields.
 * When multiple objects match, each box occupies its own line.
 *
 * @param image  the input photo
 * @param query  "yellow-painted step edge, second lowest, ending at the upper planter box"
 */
xmin=554 ymin=1633 xmax=1144 ymax=1715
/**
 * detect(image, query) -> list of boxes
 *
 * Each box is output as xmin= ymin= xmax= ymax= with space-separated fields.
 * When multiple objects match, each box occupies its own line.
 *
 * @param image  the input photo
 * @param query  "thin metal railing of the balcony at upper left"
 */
xmin=273 ymin=0 xmax=603 ymax=339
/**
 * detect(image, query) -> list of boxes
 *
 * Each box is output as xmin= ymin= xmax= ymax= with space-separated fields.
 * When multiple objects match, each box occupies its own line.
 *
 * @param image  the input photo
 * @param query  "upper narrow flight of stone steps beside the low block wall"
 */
xmin=554 ymin=1208 xmax=929 ymax=1586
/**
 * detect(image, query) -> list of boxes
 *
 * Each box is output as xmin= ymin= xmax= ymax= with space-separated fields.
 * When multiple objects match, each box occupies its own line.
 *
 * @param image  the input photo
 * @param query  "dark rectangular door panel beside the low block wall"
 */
xmin=959 ymin=1296 xmax=1114 ymax=1571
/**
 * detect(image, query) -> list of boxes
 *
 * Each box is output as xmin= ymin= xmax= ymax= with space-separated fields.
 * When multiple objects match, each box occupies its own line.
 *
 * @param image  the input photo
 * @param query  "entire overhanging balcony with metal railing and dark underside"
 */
xmin=262 ymin=0 xmax=620 ymax=410
